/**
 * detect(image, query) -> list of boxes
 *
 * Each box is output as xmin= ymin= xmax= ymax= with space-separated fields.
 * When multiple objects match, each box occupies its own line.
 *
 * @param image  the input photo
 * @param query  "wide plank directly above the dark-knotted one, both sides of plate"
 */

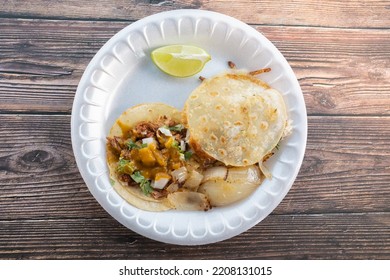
xmin=0 ymin=19 xmax=390 ymax=115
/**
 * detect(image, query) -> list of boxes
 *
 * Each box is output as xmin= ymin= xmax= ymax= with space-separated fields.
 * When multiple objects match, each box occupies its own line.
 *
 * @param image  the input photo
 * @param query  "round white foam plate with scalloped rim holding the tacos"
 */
xmin=71 ymin=10 xmax=307 ymax=245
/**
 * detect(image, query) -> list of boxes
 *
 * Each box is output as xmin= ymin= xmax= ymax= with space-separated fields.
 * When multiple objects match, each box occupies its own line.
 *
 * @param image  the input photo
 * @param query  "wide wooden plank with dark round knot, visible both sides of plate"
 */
xmin=0 ymin=115 xmax=390 ymax=220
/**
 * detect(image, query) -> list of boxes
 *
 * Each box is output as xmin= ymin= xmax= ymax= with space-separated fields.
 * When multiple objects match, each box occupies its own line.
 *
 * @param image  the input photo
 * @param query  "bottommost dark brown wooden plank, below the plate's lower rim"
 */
xmin=0 ymin=213 xmax=390 ymax=259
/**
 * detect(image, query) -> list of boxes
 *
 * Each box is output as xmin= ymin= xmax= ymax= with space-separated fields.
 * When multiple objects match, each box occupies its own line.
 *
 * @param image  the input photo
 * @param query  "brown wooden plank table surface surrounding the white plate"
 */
xmin=0 ymin=0 xmax=390 ymax=259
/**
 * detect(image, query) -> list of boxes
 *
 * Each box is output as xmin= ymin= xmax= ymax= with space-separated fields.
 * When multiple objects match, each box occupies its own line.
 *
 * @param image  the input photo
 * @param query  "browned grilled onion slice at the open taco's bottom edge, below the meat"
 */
xmin=167 ymin=191 xmax=211 ymax=211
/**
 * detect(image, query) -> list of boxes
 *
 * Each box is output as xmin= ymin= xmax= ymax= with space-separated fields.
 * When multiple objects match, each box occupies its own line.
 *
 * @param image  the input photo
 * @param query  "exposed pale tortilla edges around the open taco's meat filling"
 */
xmin=107 ymin=103 xmax=182 ymax=211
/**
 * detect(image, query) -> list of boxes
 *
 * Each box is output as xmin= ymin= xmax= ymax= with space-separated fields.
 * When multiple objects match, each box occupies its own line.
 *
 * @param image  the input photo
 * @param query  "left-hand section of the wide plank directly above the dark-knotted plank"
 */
xmin=0 ymin=19 xmax=122 ymax=112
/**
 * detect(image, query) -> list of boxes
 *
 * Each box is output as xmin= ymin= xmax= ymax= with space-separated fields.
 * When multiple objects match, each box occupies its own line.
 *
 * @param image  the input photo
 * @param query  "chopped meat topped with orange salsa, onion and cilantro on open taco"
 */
xmin=107 ymin=117 xmax=191 ymax=199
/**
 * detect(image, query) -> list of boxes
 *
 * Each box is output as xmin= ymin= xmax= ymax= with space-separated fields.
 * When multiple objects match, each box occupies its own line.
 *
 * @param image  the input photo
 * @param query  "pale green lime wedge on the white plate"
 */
xmin=151 ymin=45 xmax=211 ymax=78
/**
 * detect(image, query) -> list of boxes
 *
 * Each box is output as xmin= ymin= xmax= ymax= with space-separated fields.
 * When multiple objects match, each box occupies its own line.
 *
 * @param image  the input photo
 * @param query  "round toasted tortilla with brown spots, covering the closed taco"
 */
xmin=184 ymin=71 xmax=287 ymax=166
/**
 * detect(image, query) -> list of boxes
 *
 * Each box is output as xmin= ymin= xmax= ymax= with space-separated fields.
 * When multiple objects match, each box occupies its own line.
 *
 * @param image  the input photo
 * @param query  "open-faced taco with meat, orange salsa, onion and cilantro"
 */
xmin=107 ymin=103 xmax=210 ymax=211
